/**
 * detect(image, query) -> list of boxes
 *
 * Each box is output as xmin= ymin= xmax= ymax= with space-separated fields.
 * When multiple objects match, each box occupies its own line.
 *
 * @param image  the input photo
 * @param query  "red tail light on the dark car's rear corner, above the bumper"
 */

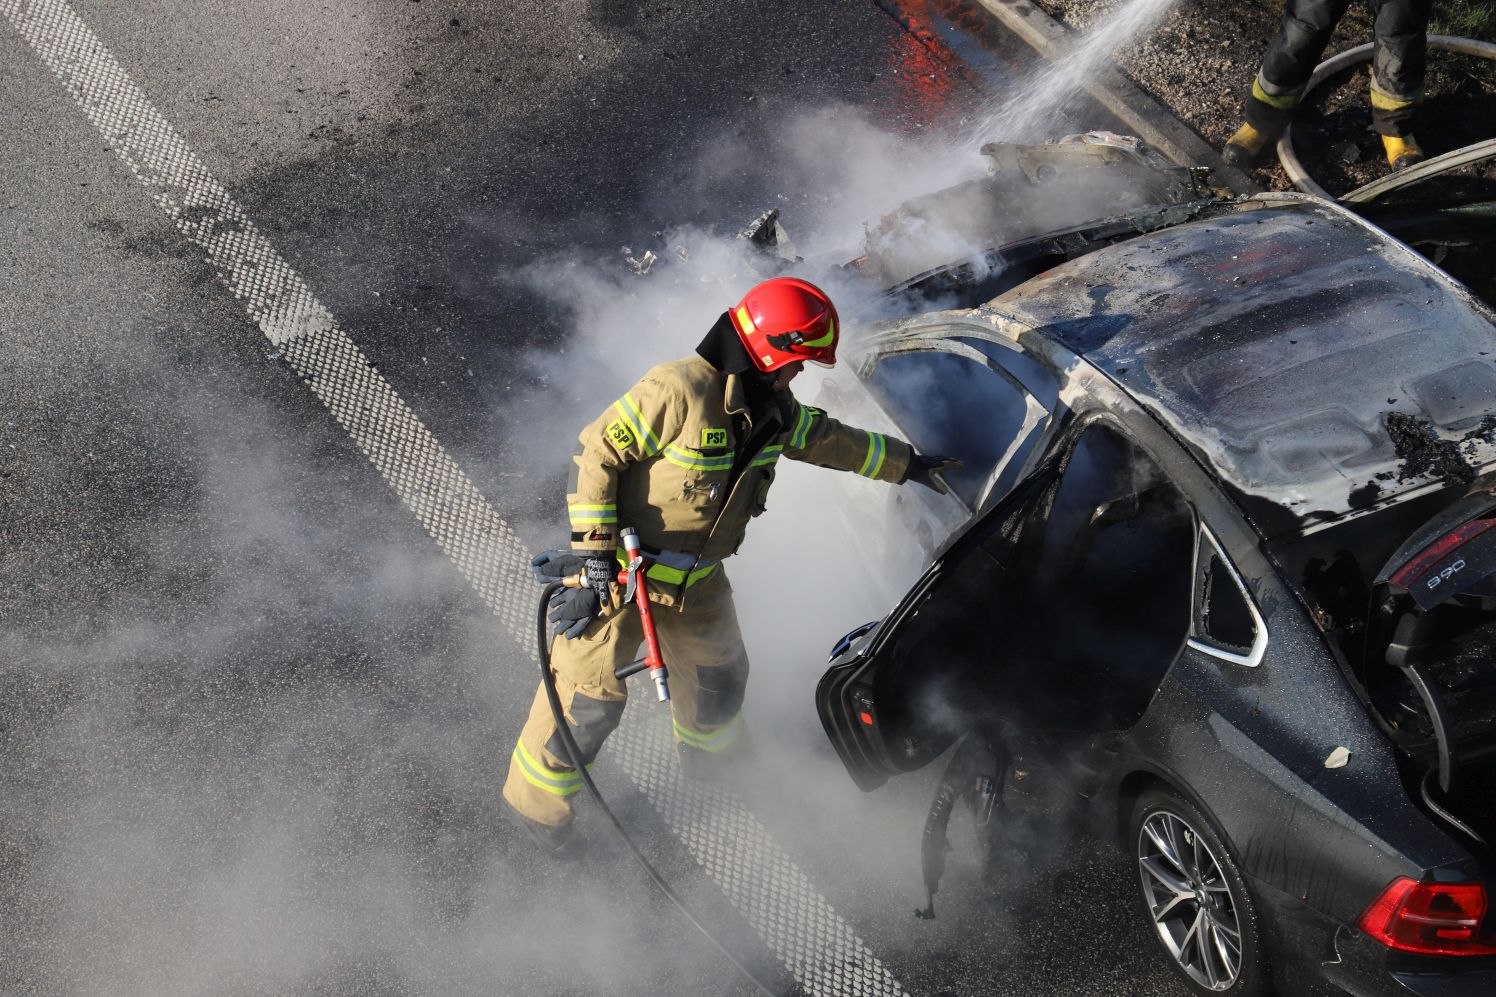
xmin=1357 ymin=876 xmax=1496 ymax=955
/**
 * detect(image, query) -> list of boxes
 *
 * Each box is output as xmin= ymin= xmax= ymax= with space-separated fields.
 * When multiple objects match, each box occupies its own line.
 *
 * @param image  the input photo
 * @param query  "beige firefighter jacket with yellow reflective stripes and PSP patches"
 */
xmin=567 ymin=356 xmax=913 ymax=605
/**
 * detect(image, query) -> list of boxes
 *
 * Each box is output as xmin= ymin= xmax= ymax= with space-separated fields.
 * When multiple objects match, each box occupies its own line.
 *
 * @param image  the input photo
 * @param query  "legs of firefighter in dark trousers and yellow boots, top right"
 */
xmin=1222 ymin=0 xmax=1433 ymax=171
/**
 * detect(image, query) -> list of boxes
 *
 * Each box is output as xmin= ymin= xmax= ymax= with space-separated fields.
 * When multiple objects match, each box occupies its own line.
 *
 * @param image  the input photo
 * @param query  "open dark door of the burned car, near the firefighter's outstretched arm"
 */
xmin=815 ymin=419 xmax=1197 ymax=789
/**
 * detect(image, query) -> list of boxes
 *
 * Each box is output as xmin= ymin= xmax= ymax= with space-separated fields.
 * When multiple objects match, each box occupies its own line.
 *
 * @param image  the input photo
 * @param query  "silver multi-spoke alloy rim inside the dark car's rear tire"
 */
xmin=1137 ymin=810 xmax=1242 ymax=991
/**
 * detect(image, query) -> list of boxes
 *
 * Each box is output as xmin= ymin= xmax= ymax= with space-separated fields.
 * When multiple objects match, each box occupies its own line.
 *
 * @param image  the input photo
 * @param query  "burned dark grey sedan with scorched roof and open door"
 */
xmin=817 ymin=160 xmax=1496 ymax=994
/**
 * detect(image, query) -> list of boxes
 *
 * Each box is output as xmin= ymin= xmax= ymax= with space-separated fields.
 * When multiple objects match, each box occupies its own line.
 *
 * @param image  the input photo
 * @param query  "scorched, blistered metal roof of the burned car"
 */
xmin=984 ymin=195 xmax=1496 ymax=537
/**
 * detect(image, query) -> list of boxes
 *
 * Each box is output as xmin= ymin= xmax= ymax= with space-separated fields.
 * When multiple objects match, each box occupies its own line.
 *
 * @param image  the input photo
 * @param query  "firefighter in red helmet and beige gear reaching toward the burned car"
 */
xmin=504 ymin=277 xmax=960 ymax=856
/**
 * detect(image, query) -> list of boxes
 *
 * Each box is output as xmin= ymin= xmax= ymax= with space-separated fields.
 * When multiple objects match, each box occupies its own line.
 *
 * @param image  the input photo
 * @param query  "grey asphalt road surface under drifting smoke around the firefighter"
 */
xmin=0 ymin=0 xmax=1177 ymax=994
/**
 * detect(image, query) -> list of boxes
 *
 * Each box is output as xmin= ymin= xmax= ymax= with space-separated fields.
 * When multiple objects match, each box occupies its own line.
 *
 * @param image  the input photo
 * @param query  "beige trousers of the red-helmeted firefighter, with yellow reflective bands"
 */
xmin=504 ymin=569 xmax=748 ymax=825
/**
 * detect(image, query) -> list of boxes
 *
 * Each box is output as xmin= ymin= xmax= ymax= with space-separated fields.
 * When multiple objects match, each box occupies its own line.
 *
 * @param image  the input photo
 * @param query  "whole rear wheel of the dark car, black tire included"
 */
xmin=1129 ymin=786 xmax=1273 ymax=997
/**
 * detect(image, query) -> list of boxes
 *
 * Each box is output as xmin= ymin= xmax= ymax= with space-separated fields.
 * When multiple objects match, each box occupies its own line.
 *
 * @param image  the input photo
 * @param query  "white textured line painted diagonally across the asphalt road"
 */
xmin=0 ymin=0 xmax=905 ymax=997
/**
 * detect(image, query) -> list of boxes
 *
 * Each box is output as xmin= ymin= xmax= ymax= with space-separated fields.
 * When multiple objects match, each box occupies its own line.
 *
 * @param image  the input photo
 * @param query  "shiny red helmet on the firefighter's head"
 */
xmin=729 ymin=277 xmax=841 ymax=374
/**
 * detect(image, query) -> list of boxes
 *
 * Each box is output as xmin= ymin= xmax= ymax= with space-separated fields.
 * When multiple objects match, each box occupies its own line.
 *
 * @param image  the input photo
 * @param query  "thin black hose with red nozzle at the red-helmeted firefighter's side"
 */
xmin=536 ymin=527 xmax=781 ymax=997
